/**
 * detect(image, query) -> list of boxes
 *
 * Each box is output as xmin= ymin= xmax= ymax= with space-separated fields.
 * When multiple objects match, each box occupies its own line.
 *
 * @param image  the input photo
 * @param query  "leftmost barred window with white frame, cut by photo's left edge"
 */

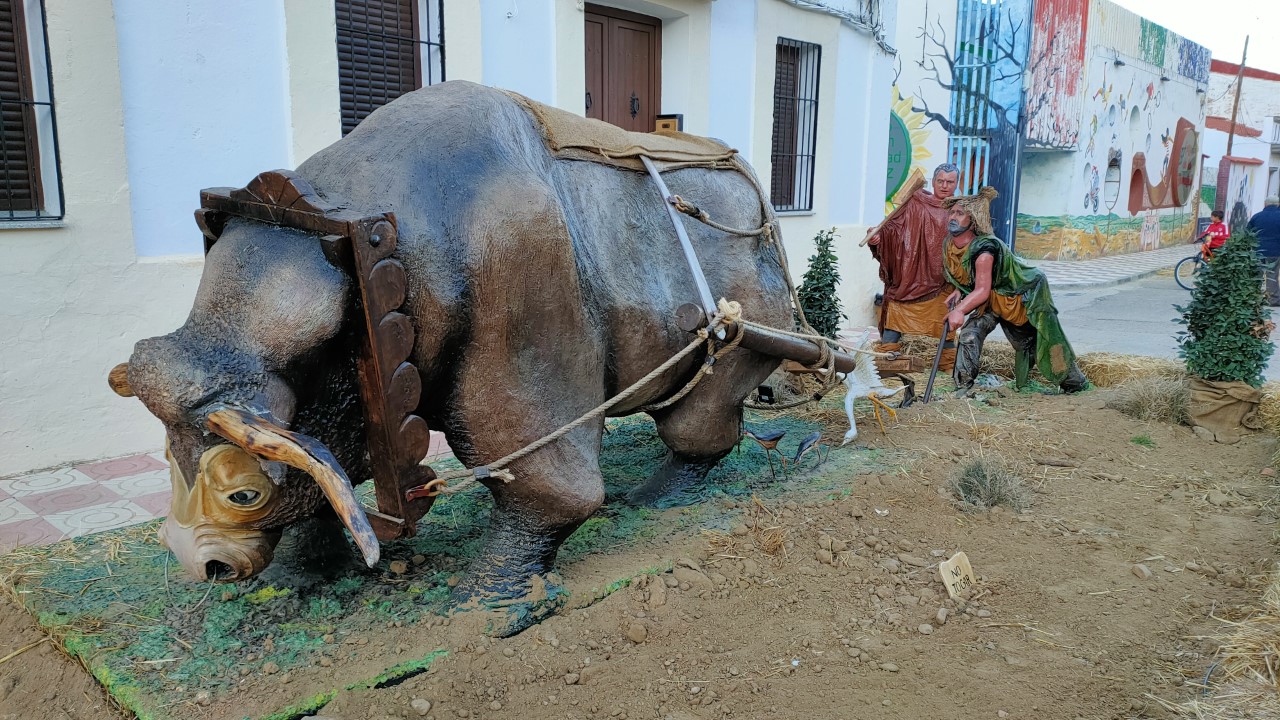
xmin=0 ymin=0 xmax=64 ymax=225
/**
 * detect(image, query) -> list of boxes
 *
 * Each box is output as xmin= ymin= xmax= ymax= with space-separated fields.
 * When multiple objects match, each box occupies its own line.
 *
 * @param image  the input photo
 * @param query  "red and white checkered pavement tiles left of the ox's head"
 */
xmin=0 ymin=433 xmax=449 ymax=552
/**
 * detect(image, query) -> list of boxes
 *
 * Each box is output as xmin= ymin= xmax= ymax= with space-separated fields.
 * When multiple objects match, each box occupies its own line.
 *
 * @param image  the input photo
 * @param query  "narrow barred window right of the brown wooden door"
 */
xmin=769 ymin=37 xmax=822 ymax=211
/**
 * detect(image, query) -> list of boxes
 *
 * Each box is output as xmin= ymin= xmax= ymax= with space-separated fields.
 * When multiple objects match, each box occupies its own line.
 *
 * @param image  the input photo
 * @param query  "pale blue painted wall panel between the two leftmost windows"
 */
xmin=115 ymin=0 xmax=293 ymax=258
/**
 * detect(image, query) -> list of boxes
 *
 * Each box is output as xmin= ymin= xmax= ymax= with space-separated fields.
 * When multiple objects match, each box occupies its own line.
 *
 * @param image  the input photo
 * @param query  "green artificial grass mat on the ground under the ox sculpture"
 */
xmin=0 ymin=401 xmax=909 ymax=720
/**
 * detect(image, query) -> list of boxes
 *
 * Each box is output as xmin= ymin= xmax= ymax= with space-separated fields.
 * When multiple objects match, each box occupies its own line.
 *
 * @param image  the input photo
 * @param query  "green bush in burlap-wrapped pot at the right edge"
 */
xmin=1178 ymin=229 xmax=1275 ymax=443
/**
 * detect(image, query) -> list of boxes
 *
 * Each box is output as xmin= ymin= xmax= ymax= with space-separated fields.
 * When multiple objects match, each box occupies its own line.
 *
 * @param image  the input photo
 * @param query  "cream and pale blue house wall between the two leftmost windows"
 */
xmin=0 ymin=0 xmax=340 ymax=475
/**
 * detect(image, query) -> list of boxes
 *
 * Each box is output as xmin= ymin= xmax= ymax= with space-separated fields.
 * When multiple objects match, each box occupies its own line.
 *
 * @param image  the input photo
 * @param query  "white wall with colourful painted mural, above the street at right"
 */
xmin=1016 ymin=0 xmax=1210 ymax=260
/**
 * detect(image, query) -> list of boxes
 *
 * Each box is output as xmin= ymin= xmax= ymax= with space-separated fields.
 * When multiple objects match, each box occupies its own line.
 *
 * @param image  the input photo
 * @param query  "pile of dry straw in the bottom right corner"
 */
xmin=1167 ymin=575 xmax=1280 ymax=720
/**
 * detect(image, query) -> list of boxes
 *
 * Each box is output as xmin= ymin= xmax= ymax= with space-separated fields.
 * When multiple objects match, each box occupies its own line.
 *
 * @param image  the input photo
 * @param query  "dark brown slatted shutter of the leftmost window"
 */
xmin=0 ymin=0 xmax=41 ymax=210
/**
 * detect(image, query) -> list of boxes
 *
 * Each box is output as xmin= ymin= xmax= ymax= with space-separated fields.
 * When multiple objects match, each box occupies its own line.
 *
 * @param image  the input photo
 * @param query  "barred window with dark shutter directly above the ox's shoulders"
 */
xmin=335 ymin=0 xmax=444 ymax=135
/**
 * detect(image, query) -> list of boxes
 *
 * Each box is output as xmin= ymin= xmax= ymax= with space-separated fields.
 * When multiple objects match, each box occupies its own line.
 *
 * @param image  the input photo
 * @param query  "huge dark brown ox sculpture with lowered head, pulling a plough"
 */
xmin=114 ymin=82 xmax=792 ymax=632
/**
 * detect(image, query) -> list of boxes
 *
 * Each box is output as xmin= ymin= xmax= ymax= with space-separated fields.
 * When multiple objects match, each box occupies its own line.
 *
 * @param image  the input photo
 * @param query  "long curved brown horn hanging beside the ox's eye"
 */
xmin=205 ymin=405 xmax=380 ymax=568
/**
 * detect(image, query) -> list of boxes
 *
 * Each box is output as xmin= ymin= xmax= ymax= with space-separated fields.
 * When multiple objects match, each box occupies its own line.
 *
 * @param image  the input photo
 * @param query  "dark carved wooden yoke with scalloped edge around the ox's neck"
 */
xmin=196 ymin=170 xmax=435 ymax=542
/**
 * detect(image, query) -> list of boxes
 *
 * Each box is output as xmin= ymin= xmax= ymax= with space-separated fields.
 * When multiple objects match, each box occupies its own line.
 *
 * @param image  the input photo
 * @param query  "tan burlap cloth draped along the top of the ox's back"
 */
xmin=507 ymin=92 xmax=739 ymax=173
